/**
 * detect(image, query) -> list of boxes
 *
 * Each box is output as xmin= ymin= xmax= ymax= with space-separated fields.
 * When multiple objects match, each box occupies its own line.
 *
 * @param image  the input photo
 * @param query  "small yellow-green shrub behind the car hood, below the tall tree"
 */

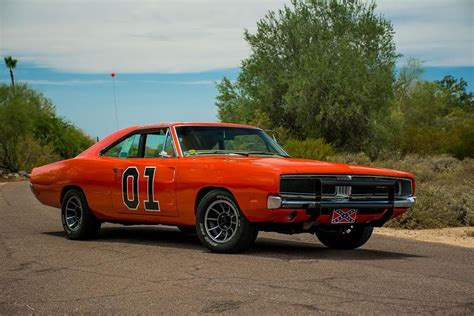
xmin=283 ymin=138 xmax=335 ymax=160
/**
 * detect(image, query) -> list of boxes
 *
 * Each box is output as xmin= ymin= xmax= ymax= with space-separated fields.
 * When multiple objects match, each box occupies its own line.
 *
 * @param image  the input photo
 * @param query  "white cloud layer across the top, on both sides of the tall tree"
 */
xmin=0 ymin=0 xmax=474 ymax=73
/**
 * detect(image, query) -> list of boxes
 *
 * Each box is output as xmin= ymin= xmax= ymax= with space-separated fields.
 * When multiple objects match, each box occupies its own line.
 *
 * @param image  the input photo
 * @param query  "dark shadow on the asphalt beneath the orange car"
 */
xmin=43 ymin=226 xmax=421 ymax=260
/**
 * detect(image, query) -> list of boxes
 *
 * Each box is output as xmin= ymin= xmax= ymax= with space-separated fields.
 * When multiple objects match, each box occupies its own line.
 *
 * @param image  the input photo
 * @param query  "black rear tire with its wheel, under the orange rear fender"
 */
xmin=61 ymin=189 xmax=101 ymax=240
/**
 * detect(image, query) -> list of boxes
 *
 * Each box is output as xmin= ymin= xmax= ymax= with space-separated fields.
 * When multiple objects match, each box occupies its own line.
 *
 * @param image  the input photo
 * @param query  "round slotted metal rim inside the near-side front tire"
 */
xmin=204 ymin=200 xmax=239 ymax=243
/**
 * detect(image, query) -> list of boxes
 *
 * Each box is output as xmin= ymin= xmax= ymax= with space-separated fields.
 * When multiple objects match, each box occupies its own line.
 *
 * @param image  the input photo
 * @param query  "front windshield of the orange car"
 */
xmin=176 ymin=126 xmax=288 ymax=157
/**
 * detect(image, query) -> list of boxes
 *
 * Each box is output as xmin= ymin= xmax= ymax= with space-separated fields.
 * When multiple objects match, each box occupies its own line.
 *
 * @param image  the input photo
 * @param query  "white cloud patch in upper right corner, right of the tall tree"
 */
xmin=377 ymin=0 xmax=474 ymax=66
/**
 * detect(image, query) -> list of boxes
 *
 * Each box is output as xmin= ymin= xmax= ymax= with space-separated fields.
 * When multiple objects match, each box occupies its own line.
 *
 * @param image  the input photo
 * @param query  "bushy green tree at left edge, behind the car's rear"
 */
xmin=0 ymin=84 xmax=93 ymax=171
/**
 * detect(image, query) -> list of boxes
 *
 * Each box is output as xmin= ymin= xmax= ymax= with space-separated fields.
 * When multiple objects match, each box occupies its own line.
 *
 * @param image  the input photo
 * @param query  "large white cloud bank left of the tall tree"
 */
xmin=0 ymin=0 xmax=283 ymax=73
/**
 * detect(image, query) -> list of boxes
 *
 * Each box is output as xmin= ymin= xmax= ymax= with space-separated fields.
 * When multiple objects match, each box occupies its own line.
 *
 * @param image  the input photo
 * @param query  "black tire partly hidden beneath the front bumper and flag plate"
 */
xmin=316 ymin=226 xmax=374 ymax=249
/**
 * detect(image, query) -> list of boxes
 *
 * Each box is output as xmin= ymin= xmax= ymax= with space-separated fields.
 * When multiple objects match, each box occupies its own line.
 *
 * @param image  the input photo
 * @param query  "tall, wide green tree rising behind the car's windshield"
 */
xmin=216 ymin=0 xmax=398 ymax=150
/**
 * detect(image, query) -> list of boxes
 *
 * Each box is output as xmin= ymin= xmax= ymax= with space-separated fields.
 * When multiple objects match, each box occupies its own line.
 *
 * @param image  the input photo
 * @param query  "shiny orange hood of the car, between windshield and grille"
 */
xmin=202 ymin=156 xmax=413 ymax=179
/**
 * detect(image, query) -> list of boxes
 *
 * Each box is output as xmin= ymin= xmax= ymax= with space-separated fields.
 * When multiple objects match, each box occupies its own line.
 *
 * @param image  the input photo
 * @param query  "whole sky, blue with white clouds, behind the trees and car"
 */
xmin=0 ymin=0 xmax=474 ymax=137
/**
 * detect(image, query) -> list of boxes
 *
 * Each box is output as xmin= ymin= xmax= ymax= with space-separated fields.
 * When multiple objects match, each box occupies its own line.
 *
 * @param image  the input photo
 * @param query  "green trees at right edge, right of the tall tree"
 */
xmin=392 ymin=59 xmax=474 ymax=158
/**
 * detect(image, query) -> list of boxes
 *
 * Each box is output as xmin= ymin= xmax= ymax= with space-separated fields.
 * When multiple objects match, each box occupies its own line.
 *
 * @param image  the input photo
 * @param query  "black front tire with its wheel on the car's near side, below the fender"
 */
xmin=196 ymin=190 xmax=258 ymax=253
